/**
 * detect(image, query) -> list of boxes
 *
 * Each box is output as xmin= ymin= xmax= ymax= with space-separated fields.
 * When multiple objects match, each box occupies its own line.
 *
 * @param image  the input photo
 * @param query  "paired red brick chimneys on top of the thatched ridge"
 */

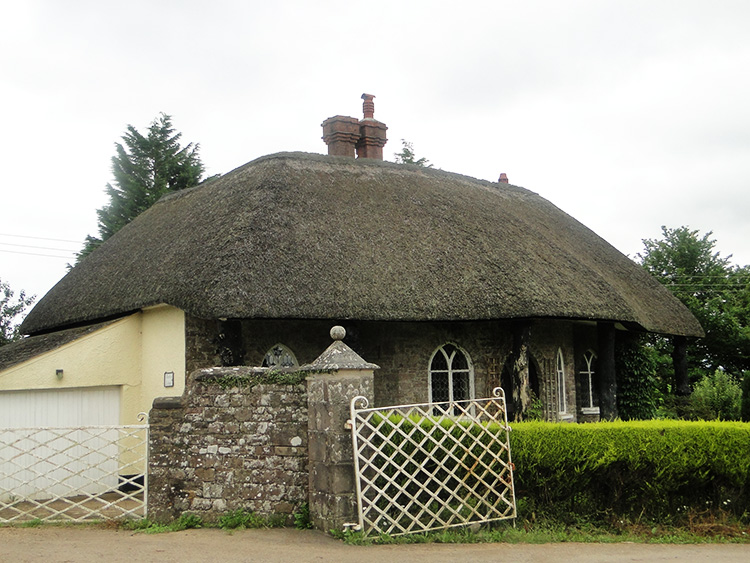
xmin=322 ymin=94 xmax=388 ymax=160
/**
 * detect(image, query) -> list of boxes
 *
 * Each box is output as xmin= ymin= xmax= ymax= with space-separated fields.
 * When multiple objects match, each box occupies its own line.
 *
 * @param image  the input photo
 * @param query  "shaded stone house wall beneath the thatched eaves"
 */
xmin=188 ymin=320 xmax=608 ymax=420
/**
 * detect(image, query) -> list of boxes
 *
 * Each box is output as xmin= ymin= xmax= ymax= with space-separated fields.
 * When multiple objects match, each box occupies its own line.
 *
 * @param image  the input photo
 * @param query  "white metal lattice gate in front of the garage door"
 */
xmin=0 ymin=416 xmax=148 ymax=522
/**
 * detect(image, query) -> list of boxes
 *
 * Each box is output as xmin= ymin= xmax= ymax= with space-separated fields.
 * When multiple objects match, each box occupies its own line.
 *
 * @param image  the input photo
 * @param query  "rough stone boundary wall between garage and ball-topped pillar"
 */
xmin=148 ymin=368 xmax=309 ymax=521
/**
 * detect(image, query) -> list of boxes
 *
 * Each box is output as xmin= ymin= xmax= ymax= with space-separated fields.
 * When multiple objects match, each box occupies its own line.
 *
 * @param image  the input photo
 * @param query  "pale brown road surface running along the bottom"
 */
xmin=0 ymin=526 xmax=750 ymax=563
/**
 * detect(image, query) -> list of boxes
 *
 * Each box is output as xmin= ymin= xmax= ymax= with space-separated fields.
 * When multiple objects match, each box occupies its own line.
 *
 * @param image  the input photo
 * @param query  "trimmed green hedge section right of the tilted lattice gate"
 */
xmin=511 ymin=420 xmax=750 ymax=521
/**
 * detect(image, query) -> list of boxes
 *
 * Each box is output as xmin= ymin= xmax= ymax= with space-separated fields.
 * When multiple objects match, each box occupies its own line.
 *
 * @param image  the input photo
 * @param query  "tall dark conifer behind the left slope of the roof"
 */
xmin=78 ymin=113 xmax=205 ymax=261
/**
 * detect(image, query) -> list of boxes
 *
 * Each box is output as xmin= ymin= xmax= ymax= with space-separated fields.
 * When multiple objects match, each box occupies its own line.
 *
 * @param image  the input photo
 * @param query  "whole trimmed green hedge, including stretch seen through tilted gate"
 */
xmin=366 ymin=416 xmax=750 ymax=526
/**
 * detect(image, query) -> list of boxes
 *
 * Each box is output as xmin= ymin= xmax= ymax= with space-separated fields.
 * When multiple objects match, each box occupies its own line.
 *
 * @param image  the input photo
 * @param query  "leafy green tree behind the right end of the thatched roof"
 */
xmin=638 ymin=227 xmax=750 ymax=381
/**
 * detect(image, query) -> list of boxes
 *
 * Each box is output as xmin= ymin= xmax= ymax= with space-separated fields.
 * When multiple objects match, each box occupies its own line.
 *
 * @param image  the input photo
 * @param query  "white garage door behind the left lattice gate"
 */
xmin=0 ymin=387 xmax=120 ymax=503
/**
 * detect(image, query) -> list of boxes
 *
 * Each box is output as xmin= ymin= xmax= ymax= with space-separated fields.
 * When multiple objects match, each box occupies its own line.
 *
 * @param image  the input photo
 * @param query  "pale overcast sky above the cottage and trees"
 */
xmin=0 ymin=0 xmax=750 ymax=308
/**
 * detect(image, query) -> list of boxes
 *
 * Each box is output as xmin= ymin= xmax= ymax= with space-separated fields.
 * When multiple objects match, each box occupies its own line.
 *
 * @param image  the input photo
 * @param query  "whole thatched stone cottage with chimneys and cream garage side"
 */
xmin=0 ymin=95 xmax=703 ymax=423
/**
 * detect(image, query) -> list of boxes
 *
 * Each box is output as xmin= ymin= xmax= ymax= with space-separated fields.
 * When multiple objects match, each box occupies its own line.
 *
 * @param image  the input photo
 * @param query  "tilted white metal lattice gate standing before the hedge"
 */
xmin=350 ymin=387 xmax=516 ymax=535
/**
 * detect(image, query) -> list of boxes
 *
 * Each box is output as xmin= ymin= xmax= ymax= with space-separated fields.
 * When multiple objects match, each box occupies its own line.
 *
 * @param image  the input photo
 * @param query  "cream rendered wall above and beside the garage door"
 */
xmin=0 ymin=305 xmax=185 ymax=424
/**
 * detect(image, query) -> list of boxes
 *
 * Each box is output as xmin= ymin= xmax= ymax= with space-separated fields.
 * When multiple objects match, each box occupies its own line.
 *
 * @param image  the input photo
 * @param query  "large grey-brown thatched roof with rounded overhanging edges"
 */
xmin=22 ymin=153 xmax=703 ymax=335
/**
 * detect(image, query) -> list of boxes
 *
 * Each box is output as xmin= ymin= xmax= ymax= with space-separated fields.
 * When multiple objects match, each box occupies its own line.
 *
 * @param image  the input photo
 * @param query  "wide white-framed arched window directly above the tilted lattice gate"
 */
xmin=429 ymin=344 xmax=474 ymax=403
